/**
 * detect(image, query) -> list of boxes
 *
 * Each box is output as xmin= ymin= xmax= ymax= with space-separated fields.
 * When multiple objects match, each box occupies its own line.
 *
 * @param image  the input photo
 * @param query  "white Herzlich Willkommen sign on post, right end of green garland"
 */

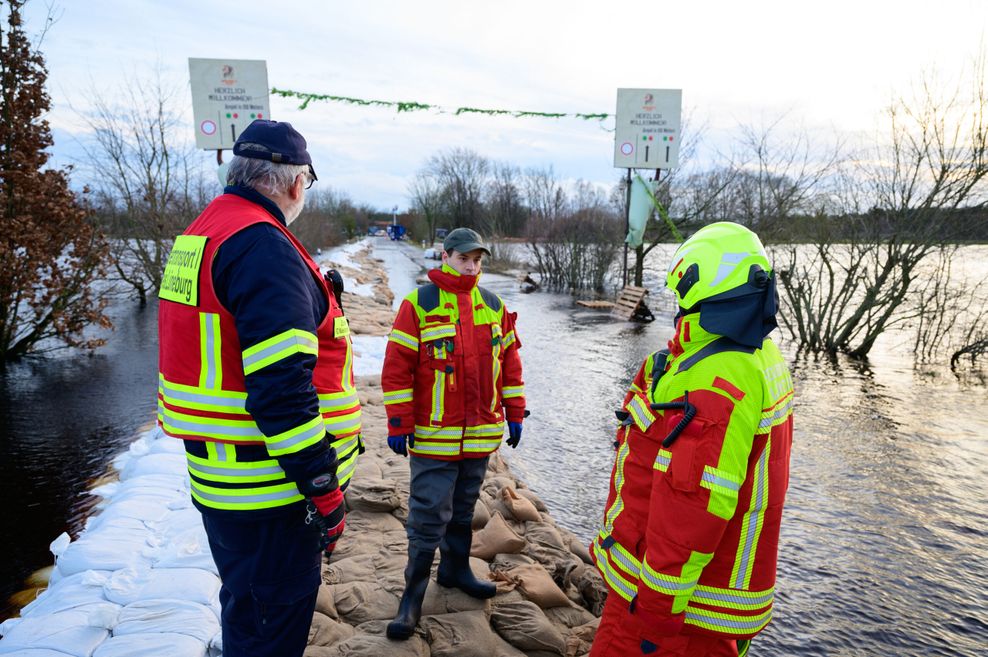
xmin=614 ymin=89 xmax=683 ymax=169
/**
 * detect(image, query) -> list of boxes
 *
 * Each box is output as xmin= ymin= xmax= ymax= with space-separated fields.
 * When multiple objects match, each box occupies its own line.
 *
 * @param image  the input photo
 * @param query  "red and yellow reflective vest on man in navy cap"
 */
xmin=158 ymin=194 xmax=361 ymax=511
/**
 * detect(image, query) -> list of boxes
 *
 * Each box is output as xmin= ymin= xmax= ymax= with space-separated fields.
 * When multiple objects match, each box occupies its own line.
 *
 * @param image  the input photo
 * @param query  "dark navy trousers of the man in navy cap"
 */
xmin=203 ymin=505 xmax=322 ymax=657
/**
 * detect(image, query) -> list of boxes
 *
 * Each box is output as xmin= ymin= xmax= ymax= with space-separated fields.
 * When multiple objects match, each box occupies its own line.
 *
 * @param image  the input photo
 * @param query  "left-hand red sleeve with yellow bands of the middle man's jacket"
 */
xmin=381 ymin=299 xmax=420 ymax=436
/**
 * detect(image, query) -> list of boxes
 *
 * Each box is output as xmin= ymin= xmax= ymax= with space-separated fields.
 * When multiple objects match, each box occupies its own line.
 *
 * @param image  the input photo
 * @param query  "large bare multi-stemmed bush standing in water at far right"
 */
xmin=776 ymin=57 xmax=988 ymax=357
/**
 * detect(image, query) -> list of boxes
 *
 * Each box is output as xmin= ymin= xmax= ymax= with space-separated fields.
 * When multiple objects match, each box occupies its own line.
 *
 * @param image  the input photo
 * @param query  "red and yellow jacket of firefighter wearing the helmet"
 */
xmin=590 ymin=314 xmax=793 ymax=642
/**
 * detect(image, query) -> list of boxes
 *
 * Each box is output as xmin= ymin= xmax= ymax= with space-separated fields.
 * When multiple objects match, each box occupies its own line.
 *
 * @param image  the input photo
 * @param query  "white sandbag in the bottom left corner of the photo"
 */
xmin=0 ymin=611 xmax=110 ymax=657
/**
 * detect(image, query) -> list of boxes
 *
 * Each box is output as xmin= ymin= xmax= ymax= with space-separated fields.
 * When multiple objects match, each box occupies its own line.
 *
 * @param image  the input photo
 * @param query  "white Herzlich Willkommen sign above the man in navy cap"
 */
xmin=189 ymin=57 xmax=271 ymax=150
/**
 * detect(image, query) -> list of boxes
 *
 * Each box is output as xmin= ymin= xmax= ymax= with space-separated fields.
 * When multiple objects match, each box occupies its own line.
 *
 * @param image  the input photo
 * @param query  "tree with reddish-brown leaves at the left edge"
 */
xmin=0 ymin=0 xmax=109 ymax=361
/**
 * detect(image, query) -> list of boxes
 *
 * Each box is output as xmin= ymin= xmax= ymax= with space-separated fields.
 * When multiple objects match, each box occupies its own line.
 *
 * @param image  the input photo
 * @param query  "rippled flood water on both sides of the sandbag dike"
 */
xmin=0 ymin=240 xmax=988 ymax=657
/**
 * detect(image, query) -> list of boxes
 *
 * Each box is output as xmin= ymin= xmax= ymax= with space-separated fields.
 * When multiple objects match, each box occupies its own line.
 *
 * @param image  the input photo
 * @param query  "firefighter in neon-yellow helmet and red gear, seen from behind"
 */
xmin=590 ymin=222 xmax=793 ymax=657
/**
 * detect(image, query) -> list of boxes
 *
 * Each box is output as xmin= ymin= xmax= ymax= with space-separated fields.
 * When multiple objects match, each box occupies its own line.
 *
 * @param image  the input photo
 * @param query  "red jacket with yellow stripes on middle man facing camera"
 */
xmin=381 ymin=265 xmax=525 ymax=460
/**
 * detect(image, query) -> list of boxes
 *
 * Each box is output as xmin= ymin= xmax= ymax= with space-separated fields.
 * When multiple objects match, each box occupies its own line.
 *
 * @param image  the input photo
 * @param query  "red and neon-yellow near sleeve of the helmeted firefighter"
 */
xmin=633 ymin=377 xmax=761 ymax=642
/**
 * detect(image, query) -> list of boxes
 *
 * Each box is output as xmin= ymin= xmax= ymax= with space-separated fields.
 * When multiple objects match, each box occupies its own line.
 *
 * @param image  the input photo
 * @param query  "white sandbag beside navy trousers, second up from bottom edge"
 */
xmin=113 ymin=598 xmax=220 ymax=644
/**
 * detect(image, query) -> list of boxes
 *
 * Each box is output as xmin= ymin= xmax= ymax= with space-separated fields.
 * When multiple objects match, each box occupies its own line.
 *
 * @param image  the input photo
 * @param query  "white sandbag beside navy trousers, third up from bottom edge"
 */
xmin=103 ymin=568 xmax=220 ymax=605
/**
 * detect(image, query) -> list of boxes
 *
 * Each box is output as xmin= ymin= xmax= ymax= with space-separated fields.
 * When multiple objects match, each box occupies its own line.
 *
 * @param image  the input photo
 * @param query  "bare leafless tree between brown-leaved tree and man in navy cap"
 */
xmin=83 ymin=70 xmax=208 ymax=305
